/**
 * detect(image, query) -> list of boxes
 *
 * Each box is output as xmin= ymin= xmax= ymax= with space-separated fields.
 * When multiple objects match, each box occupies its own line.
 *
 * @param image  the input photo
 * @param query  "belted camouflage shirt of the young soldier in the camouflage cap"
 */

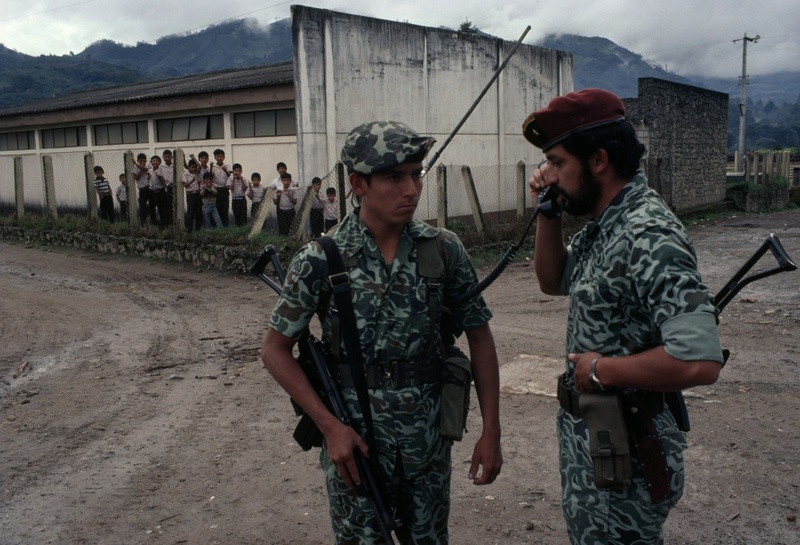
xmin=269 ymin=213 xmax=491 ymax=476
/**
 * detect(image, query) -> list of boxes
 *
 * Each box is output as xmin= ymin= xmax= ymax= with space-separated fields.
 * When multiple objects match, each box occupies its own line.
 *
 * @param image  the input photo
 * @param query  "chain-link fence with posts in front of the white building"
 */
xmin=0 ymin=148 xmax=535 ymax=244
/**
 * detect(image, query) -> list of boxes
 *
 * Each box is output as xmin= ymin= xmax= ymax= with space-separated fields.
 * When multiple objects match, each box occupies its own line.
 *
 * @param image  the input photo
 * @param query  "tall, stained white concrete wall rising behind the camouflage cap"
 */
xmin=292 ymin=5 xmax=573 ymax=199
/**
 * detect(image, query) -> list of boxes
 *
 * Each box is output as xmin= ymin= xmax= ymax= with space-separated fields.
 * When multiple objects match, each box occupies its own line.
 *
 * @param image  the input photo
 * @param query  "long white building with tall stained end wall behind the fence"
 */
xmin=0 ymin=6 xmax=572 ymax=219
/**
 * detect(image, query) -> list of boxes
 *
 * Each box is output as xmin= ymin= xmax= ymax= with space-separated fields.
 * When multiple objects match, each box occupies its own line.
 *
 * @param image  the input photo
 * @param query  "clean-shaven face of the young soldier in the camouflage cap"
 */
xmin=350 ymin=162 xmax=422 ymax=225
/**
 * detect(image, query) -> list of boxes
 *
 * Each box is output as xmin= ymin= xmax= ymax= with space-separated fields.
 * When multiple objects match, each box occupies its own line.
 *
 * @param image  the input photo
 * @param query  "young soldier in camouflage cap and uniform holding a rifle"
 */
xmin=262 ymin=121 xmax=502 ymax=545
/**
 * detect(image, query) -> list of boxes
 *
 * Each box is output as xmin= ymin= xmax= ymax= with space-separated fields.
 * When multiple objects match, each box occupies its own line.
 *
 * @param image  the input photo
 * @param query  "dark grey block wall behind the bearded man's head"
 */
xmin=624 ymin=78 xmax=728 ymax=211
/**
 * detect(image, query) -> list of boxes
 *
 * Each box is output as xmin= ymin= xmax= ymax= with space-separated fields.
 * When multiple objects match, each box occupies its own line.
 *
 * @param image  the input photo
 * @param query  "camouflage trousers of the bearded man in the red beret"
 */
xmin=556 ymin=408 xmax=686 ymax=545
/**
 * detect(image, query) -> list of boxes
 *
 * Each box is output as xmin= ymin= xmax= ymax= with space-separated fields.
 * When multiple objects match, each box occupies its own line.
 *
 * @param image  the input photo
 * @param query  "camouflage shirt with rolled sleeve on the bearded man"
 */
xmin=561 ymin=172 xmax=722 ymax=378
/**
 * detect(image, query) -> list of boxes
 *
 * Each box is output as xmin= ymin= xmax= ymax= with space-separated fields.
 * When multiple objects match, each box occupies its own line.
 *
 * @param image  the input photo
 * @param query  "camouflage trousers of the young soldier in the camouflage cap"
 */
xmin=320 ymin=441 xmax=452 ymax=545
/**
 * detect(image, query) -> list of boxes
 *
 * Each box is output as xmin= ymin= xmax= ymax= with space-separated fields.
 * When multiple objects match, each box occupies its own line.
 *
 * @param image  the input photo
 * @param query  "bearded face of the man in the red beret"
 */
xmin=545 ymin=144 xmax=600 ymax=216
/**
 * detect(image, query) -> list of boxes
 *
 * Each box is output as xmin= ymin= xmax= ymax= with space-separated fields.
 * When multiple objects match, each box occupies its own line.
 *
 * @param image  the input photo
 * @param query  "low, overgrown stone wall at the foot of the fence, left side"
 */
xmin=0 ymin=226 xmax=258 ymax=273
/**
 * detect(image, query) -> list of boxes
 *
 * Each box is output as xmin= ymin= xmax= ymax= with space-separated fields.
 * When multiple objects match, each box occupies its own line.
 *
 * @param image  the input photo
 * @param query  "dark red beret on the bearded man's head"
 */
xmin=522 ymin=89 xmax=625 ymax=151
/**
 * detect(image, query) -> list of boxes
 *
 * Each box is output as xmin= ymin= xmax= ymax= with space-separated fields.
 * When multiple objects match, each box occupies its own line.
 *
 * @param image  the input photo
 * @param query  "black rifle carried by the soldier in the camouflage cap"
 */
xmin=250 ymin=244 xmax=401 ymax=545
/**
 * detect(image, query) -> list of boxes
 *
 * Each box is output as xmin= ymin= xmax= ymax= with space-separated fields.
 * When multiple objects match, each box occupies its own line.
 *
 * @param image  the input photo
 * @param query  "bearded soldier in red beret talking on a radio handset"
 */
xmin=523 ymin=89 xmax=723 ymax=545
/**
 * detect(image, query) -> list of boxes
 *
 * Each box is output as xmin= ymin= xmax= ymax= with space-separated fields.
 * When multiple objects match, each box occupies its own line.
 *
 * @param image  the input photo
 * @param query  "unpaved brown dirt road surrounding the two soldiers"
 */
xmin=0 ymin=212 xmax=800 ymax=545
